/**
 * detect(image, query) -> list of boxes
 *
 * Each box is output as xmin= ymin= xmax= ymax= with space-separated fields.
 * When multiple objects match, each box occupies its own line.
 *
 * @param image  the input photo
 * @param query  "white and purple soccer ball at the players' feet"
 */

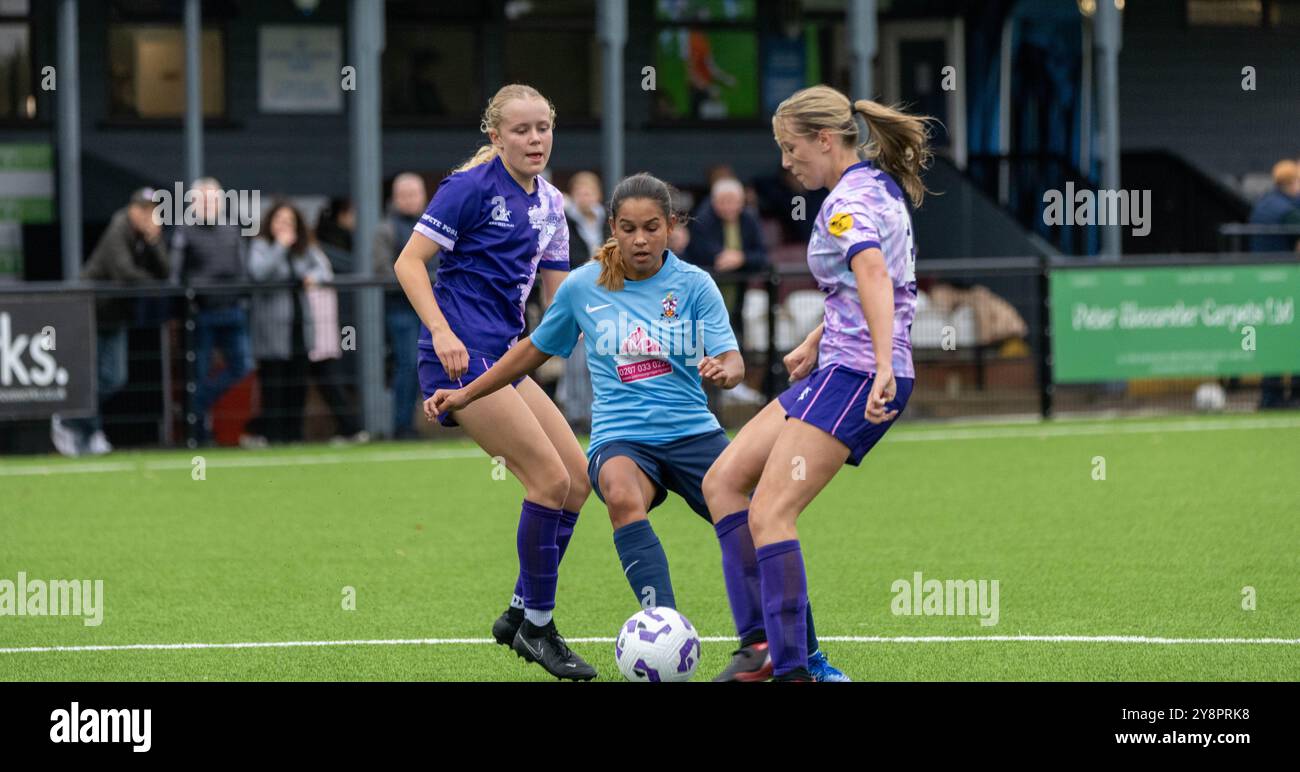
xmin=614 ymin=608 xmax=699 ymax=681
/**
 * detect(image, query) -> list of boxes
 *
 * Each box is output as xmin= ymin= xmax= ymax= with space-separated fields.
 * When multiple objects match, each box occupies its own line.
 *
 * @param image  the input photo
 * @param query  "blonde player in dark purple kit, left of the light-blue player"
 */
xmin=394 ymin=84 xmax=595 ymax=680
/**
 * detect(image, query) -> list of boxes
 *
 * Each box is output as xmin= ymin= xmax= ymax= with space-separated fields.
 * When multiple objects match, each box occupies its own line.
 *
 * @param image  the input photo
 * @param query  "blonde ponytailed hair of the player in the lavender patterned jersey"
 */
xmin=772 ymin=86 xmax=937 ymax=207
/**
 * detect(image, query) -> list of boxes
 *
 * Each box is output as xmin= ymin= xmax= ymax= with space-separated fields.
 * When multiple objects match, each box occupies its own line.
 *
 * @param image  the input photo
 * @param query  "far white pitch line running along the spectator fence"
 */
xmin=0 ymin=416 xmax=1300 ymax=477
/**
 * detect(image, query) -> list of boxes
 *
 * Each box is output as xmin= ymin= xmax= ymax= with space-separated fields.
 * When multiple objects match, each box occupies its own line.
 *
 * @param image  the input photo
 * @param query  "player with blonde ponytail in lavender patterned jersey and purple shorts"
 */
xmin=705 ymin=86 xmax=931 ymax=680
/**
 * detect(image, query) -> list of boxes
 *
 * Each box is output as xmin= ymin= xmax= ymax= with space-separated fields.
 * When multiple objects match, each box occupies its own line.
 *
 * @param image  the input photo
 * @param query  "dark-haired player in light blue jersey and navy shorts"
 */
xmin=425 ymin=174 xmax=848 ymax=680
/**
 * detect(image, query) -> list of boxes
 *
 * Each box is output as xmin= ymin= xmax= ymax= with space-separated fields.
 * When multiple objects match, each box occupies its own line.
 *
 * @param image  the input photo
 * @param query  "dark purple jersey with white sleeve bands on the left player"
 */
xmin=415 ymin=156 xmax=568 ymax=359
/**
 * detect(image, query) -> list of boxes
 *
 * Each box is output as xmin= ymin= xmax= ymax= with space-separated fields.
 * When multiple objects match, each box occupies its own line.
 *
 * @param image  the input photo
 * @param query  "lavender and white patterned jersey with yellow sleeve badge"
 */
xmin=809 ymin=161 xmax=917 ymax=378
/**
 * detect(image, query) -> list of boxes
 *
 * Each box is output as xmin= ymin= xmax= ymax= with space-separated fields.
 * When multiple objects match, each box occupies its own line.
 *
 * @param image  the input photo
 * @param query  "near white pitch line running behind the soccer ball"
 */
xmin=0 ymin=636 xmax=1300 ymax=654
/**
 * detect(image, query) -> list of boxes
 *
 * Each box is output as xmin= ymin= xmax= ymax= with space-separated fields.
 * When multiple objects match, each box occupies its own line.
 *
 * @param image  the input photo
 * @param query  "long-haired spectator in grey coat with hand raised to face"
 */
xmin=241 ymin=201 xmax=369 ymax=446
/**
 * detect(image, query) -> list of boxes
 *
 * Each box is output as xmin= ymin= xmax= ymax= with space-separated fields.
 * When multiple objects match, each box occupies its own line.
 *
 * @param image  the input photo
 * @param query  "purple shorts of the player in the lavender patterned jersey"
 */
xmin=776 ymin=365 xmax=913 ymax=467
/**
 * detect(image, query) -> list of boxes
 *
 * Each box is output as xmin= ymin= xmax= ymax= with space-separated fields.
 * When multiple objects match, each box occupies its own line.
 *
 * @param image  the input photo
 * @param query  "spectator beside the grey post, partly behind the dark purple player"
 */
xmin=373 ymin=172 xmax=438 ymax=439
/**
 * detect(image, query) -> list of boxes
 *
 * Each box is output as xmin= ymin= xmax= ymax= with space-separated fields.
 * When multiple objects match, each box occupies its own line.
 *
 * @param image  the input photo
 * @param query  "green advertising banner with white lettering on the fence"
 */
xmin=1049 ymin=264 xmax=1300 ymax=383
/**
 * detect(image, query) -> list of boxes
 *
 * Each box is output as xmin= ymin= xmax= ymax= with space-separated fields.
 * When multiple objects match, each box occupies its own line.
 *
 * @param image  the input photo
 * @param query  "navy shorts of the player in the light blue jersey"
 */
xmin=586 ymin=429 xmax=731 ymax=522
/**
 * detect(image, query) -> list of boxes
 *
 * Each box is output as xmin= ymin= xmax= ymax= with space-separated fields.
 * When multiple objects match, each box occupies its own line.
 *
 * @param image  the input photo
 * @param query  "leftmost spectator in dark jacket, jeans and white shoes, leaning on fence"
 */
xmin=49 ymin=187 xmax=168 ymax=456
